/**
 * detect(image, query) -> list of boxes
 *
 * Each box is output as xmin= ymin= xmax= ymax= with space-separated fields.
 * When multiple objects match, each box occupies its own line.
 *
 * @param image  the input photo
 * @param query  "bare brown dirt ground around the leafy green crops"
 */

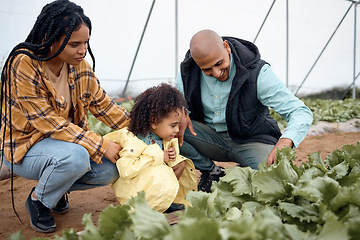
xmin=0 ymin=132 xmax=360 ymax=239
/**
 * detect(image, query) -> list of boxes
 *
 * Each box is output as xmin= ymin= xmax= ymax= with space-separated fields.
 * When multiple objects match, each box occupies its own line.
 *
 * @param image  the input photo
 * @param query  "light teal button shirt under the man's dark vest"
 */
xmin=176 ymin=53 xmax=313 ymax=147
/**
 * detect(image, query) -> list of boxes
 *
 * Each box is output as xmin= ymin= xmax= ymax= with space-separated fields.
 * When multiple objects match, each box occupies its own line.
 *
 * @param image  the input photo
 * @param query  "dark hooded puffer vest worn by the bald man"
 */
xmin=181 ymin=37 xmax=281 ymax=144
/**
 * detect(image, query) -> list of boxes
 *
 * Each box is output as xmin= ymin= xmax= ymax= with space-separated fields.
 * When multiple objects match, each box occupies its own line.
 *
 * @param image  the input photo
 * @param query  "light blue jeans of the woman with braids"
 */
xmin=4 ymin=138 xmax=119 ymax=208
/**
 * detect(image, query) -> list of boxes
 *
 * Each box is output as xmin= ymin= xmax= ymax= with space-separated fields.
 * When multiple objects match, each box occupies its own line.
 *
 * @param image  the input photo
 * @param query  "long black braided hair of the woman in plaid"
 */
xmin=0 ymin=0 xmax=95 ymax=223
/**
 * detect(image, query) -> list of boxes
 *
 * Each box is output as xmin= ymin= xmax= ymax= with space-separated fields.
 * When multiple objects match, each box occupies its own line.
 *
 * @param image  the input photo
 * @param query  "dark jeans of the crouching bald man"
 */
xmin=180 ymin=121 xmax=274 ymax=171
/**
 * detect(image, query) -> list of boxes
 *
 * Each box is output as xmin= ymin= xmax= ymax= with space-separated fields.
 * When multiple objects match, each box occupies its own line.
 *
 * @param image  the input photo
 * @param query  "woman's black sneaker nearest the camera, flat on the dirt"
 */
xmin=25 ymin=188 xmax=56 ymax=233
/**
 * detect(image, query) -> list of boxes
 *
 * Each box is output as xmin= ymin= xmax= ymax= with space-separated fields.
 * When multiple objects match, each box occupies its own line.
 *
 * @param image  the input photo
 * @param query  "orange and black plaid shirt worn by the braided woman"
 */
xmin=0 ymin=54 xmax=129 ymax=163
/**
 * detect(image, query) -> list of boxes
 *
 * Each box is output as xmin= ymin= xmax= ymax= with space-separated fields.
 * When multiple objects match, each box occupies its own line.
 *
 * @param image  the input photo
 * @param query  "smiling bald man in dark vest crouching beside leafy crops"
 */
xmin=176 ymin=30 xmax=313 ymax=192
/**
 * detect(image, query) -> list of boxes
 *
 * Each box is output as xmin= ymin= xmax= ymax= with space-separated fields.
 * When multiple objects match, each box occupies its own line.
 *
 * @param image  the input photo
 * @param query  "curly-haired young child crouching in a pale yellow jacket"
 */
xmin=105 ymin=84 xmax=197 ymax=212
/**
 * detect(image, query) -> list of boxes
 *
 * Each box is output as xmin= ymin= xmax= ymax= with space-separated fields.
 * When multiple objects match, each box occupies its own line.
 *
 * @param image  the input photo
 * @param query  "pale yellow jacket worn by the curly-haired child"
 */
xmin=105 ymin=128 xmax=197 ymax=212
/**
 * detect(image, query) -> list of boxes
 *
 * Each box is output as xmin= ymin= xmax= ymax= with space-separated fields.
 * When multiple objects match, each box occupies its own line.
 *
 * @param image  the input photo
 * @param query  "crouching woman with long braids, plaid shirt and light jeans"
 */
xmin=1 ymin=0 xmax=128 ymax=232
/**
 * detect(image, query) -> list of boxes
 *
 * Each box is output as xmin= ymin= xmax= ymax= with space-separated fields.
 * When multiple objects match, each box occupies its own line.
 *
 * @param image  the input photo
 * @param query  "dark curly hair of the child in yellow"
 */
xmin=128 ymin=83 xmax=187 ymax=136
